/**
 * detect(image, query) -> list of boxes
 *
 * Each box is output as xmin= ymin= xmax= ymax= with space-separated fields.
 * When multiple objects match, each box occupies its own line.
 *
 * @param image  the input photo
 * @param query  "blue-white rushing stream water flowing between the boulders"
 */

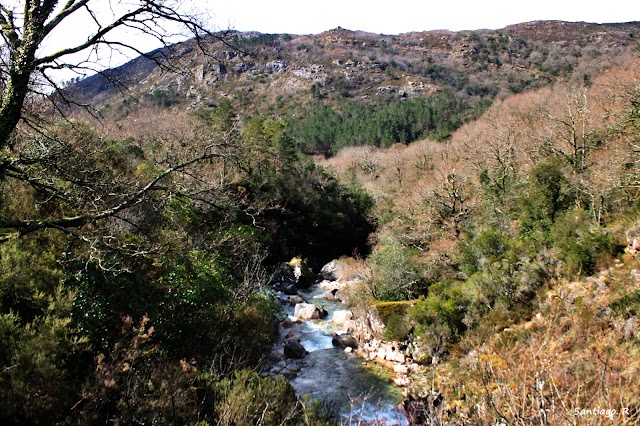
xmin=285 ymin=284 xmax=409 ymax=426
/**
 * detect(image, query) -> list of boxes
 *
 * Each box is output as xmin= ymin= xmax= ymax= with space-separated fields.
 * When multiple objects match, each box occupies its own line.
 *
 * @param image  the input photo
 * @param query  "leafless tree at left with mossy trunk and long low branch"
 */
xmin=0 ymin=0 xmax=236 ymax=242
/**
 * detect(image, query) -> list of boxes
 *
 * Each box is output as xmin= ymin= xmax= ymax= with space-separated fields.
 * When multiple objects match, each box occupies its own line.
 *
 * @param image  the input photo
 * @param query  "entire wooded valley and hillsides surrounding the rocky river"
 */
xmin=0 ymin=1 xmax=640 ymax=425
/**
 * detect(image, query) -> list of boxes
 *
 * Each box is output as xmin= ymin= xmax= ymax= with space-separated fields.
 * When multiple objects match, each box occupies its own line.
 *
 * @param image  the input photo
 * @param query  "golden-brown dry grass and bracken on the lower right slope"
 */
xmin=414 ymin=255 xmax=640 ymax=425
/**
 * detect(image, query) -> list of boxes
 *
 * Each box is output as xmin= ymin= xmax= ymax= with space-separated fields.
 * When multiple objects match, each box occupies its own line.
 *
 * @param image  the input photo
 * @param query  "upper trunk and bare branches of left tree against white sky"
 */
xmin=0 ymin=0 xmax=225 ymax=143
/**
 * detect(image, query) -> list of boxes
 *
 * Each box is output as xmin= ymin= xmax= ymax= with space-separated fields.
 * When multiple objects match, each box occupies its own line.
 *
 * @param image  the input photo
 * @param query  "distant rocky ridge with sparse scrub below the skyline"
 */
xmin=70 ymin=21 xmax=640 ymax=126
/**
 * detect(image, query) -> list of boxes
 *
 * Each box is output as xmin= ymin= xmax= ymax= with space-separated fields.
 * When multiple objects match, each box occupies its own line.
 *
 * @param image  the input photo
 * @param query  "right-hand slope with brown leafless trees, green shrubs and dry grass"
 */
xmin=319 ymin=50 xmax=640 ymax=424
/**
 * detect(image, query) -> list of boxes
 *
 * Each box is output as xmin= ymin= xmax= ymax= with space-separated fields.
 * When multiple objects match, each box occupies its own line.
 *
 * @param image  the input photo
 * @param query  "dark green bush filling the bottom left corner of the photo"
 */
xmin=0 ymin=289 xmax=87 ymax=424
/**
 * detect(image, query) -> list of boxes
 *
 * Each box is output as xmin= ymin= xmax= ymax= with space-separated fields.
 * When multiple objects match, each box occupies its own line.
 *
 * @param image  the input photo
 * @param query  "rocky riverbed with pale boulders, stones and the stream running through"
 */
xmin=269 ymin=259 xmax=416 ymax=425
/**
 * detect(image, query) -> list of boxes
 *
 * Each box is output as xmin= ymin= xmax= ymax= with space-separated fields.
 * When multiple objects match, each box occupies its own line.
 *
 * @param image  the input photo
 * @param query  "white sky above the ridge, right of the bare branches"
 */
xmin=204 ymin=0 xmax=640 ymax=34
